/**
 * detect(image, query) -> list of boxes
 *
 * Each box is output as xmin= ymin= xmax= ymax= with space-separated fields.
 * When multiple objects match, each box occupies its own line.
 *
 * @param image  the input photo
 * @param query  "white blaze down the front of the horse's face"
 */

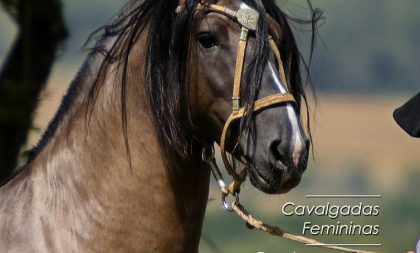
xmin=268 ymin=62 xmax=304 ymax=166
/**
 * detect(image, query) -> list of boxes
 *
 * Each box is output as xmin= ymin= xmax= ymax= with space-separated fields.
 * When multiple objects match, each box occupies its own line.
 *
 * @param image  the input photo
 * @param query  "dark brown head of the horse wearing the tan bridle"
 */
xmin=182 ymin=0 xmax=310 ymax=193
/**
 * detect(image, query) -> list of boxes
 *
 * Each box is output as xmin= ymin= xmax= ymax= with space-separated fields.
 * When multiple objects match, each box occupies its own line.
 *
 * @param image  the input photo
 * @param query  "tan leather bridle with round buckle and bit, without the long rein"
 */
xmin=176 ymin=0 xmax=296 ymax=211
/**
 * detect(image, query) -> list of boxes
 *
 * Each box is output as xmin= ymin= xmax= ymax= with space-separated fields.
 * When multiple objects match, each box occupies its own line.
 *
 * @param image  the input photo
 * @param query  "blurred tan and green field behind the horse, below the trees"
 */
xmin=30 ymin=85 xmax=420 ymax=253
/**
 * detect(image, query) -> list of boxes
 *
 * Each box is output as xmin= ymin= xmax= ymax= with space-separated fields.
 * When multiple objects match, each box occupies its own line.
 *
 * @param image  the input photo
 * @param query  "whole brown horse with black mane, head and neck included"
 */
xmin=0 ymin=0 xmax=320 ymax=252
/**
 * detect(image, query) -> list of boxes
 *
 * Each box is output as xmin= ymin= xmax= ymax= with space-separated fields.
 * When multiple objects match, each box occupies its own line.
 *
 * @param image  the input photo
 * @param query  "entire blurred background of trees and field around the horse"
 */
xmin=0 ymin=0 xmax=420 ymax=253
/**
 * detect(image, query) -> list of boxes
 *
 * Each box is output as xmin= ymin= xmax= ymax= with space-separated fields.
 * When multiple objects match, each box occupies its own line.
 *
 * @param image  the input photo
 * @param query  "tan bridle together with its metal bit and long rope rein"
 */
xmin=176 ymin=0 xmax=380 ymax=253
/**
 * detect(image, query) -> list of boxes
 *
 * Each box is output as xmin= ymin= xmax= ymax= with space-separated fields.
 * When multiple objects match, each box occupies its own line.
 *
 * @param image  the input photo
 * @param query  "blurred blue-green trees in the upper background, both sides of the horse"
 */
xmin=0 ymin=0 xmax=420 ymax=93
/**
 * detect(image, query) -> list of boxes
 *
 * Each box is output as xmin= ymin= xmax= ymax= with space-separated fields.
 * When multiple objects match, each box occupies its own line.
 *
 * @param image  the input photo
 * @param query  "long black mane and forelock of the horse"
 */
xmin=0 ymin=0 xmax=322 ymax=186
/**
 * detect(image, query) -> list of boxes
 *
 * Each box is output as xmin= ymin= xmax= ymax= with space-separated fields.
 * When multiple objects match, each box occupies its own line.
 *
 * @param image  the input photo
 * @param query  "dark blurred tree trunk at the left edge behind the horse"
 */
xmin=0 ymin=0 xmax=67 ymax=181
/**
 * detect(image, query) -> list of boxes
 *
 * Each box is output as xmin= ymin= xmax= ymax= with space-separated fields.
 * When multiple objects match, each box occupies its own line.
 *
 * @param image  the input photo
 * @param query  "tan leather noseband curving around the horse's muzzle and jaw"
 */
xmin=220 ymin=93 xmax=296 ymax=182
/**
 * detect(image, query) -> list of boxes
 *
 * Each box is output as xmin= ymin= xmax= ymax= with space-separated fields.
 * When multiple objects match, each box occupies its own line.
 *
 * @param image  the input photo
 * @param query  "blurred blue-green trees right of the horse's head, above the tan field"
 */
xmin=306 ymin=0 xmax=420 ymax=95
